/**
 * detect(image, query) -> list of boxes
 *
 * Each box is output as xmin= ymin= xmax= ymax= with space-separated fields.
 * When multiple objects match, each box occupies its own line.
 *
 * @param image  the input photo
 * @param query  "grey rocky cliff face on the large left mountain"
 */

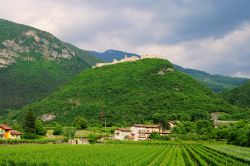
xmin=0 ymin=30 xmax=75 ymax=68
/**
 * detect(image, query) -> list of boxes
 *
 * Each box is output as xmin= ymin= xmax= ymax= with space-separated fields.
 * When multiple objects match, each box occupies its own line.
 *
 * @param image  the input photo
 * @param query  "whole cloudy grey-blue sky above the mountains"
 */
xmin=0 ymin=0 xmax=250 ymax=78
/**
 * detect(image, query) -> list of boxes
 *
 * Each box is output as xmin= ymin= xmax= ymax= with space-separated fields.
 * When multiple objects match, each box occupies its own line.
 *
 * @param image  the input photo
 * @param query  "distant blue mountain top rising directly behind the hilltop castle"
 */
xmin=89 ymin=50 xmax=140 ymax=62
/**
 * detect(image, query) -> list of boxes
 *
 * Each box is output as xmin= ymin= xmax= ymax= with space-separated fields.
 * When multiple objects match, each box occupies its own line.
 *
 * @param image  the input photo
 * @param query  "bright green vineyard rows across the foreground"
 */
xmin=0 ymin=143 xmax=250 ymax=166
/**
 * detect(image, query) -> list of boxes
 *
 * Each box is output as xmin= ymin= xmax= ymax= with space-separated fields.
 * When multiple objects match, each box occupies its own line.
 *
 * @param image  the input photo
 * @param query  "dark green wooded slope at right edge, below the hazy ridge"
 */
xmin=221 ymin=82 xmax=250 ymax=107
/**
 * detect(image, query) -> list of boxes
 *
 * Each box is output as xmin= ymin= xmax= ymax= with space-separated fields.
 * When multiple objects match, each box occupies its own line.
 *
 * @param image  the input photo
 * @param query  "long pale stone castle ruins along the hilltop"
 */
xmin=92 ymin=55 xmax=163 ymax=68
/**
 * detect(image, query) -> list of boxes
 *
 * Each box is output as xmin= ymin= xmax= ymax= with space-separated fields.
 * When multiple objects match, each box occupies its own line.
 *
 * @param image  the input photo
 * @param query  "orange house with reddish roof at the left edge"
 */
xmin=0 ymin=125 xmax=22 ymax=139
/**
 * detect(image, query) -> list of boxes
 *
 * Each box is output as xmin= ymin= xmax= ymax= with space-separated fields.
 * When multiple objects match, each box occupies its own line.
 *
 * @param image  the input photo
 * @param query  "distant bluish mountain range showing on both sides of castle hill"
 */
xmin=89 ymin=50 xmax=249 ymax=92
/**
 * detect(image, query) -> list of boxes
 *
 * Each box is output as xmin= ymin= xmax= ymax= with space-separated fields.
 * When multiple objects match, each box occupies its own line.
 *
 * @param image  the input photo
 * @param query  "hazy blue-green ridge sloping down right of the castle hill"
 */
xmin=175 ymin=65 xmax=249 ymax=92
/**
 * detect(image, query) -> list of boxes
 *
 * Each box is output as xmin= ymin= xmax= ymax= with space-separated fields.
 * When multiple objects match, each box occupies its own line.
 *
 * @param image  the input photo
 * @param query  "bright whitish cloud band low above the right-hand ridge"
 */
xmin=136 ymin=24 xmax=250 ymax=77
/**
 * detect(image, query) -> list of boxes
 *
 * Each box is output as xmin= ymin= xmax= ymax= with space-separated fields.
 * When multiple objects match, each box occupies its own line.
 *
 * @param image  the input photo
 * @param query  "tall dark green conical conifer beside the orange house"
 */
xmin=22 ymin=109 xmax=36 ymax=133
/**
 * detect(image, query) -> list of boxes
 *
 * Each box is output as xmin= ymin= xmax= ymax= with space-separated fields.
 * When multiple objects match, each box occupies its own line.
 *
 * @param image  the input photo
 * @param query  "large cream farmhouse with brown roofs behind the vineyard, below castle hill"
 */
xmin=114 ymin=124 xmax=171 ymax=141
